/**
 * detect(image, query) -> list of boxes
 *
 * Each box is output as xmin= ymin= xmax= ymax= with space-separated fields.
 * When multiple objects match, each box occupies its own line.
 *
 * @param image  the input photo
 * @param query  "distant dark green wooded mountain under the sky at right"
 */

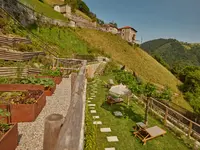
xmin=141 ymin=39 xmax=200 ymax=69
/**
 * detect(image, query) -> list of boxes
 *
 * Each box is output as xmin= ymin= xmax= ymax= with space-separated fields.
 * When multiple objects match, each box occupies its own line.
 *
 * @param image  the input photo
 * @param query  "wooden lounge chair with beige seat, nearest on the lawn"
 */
xmin=133 ymin=126 xmax=167 ymax=145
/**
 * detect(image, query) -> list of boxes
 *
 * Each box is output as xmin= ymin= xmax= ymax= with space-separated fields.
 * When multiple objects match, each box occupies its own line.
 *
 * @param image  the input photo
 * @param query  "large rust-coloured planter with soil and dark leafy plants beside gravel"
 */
xmin=0 ymin=89 xmax=46 ymax=123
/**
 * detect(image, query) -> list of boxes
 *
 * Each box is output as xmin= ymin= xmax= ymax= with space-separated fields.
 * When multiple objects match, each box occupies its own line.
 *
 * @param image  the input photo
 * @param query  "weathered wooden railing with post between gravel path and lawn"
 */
xmin=43 ymin=59 xmax=87 ymax=150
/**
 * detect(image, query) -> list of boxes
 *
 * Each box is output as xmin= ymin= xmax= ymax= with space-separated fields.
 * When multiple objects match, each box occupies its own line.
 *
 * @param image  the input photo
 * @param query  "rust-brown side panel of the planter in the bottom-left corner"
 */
xmin=0 ymin=124 xmax=18 ymax=150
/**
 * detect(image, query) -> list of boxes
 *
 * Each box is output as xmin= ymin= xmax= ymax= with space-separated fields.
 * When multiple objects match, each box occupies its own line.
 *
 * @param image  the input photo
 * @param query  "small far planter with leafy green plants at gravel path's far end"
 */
xmin=37 ymin=68 xmax=62 ymax=84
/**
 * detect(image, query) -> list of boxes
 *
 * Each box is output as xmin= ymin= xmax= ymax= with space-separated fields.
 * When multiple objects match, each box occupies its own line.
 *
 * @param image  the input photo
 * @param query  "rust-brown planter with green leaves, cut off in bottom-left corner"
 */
xmin=0 ymin=109 xmax=18 ymax=150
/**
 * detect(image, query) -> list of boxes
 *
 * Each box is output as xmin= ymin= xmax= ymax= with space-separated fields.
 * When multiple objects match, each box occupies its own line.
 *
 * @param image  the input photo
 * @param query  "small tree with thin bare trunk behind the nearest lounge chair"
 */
xmin=144 ymin=83 xmax=156 ymax=125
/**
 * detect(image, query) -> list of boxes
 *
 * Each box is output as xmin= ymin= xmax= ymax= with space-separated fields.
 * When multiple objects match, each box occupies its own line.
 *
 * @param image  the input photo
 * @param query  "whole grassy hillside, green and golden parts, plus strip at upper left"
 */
xmin=3 ymin=0 xmax=192 ymax=110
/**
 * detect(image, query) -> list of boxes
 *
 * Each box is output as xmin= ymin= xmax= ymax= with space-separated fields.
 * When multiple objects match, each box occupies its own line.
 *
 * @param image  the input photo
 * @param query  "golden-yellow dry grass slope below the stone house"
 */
xmin=76 ymin=29 xmax=191 ymax=110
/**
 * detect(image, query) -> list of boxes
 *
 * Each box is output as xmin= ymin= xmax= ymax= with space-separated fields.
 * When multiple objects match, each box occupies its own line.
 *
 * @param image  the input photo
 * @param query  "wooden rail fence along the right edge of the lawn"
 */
xmin=139 ymin=98 xmax=200 ymax=141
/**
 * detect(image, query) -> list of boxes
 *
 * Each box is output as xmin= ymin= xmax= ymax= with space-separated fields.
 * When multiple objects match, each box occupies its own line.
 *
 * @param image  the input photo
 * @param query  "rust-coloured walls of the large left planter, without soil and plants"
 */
xmin=0 ymin=84 xmax=46 ymax=123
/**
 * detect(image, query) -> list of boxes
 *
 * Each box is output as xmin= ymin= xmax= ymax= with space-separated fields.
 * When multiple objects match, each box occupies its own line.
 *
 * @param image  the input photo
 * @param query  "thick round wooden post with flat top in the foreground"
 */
xmin=43 ymin=114 xmax=63 ymax=150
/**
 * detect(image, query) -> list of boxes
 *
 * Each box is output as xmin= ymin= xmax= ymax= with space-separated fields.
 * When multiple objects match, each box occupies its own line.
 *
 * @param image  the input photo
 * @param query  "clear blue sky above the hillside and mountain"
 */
xmin=84 ymin=0 xmax=200 ymax=43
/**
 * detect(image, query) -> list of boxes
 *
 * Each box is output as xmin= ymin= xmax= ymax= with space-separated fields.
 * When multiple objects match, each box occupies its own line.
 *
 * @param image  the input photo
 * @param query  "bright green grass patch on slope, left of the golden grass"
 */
xmin=32 ymin=27 xmax=91 ymax=57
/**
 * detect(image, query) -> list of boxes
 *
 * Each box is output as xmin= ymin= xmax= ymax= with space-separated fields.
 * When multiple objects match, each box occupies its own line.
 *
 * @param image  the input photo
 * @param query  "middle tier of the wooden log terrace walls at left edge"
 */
xmin=0 ymin=47 xmax=45 ymax=61
